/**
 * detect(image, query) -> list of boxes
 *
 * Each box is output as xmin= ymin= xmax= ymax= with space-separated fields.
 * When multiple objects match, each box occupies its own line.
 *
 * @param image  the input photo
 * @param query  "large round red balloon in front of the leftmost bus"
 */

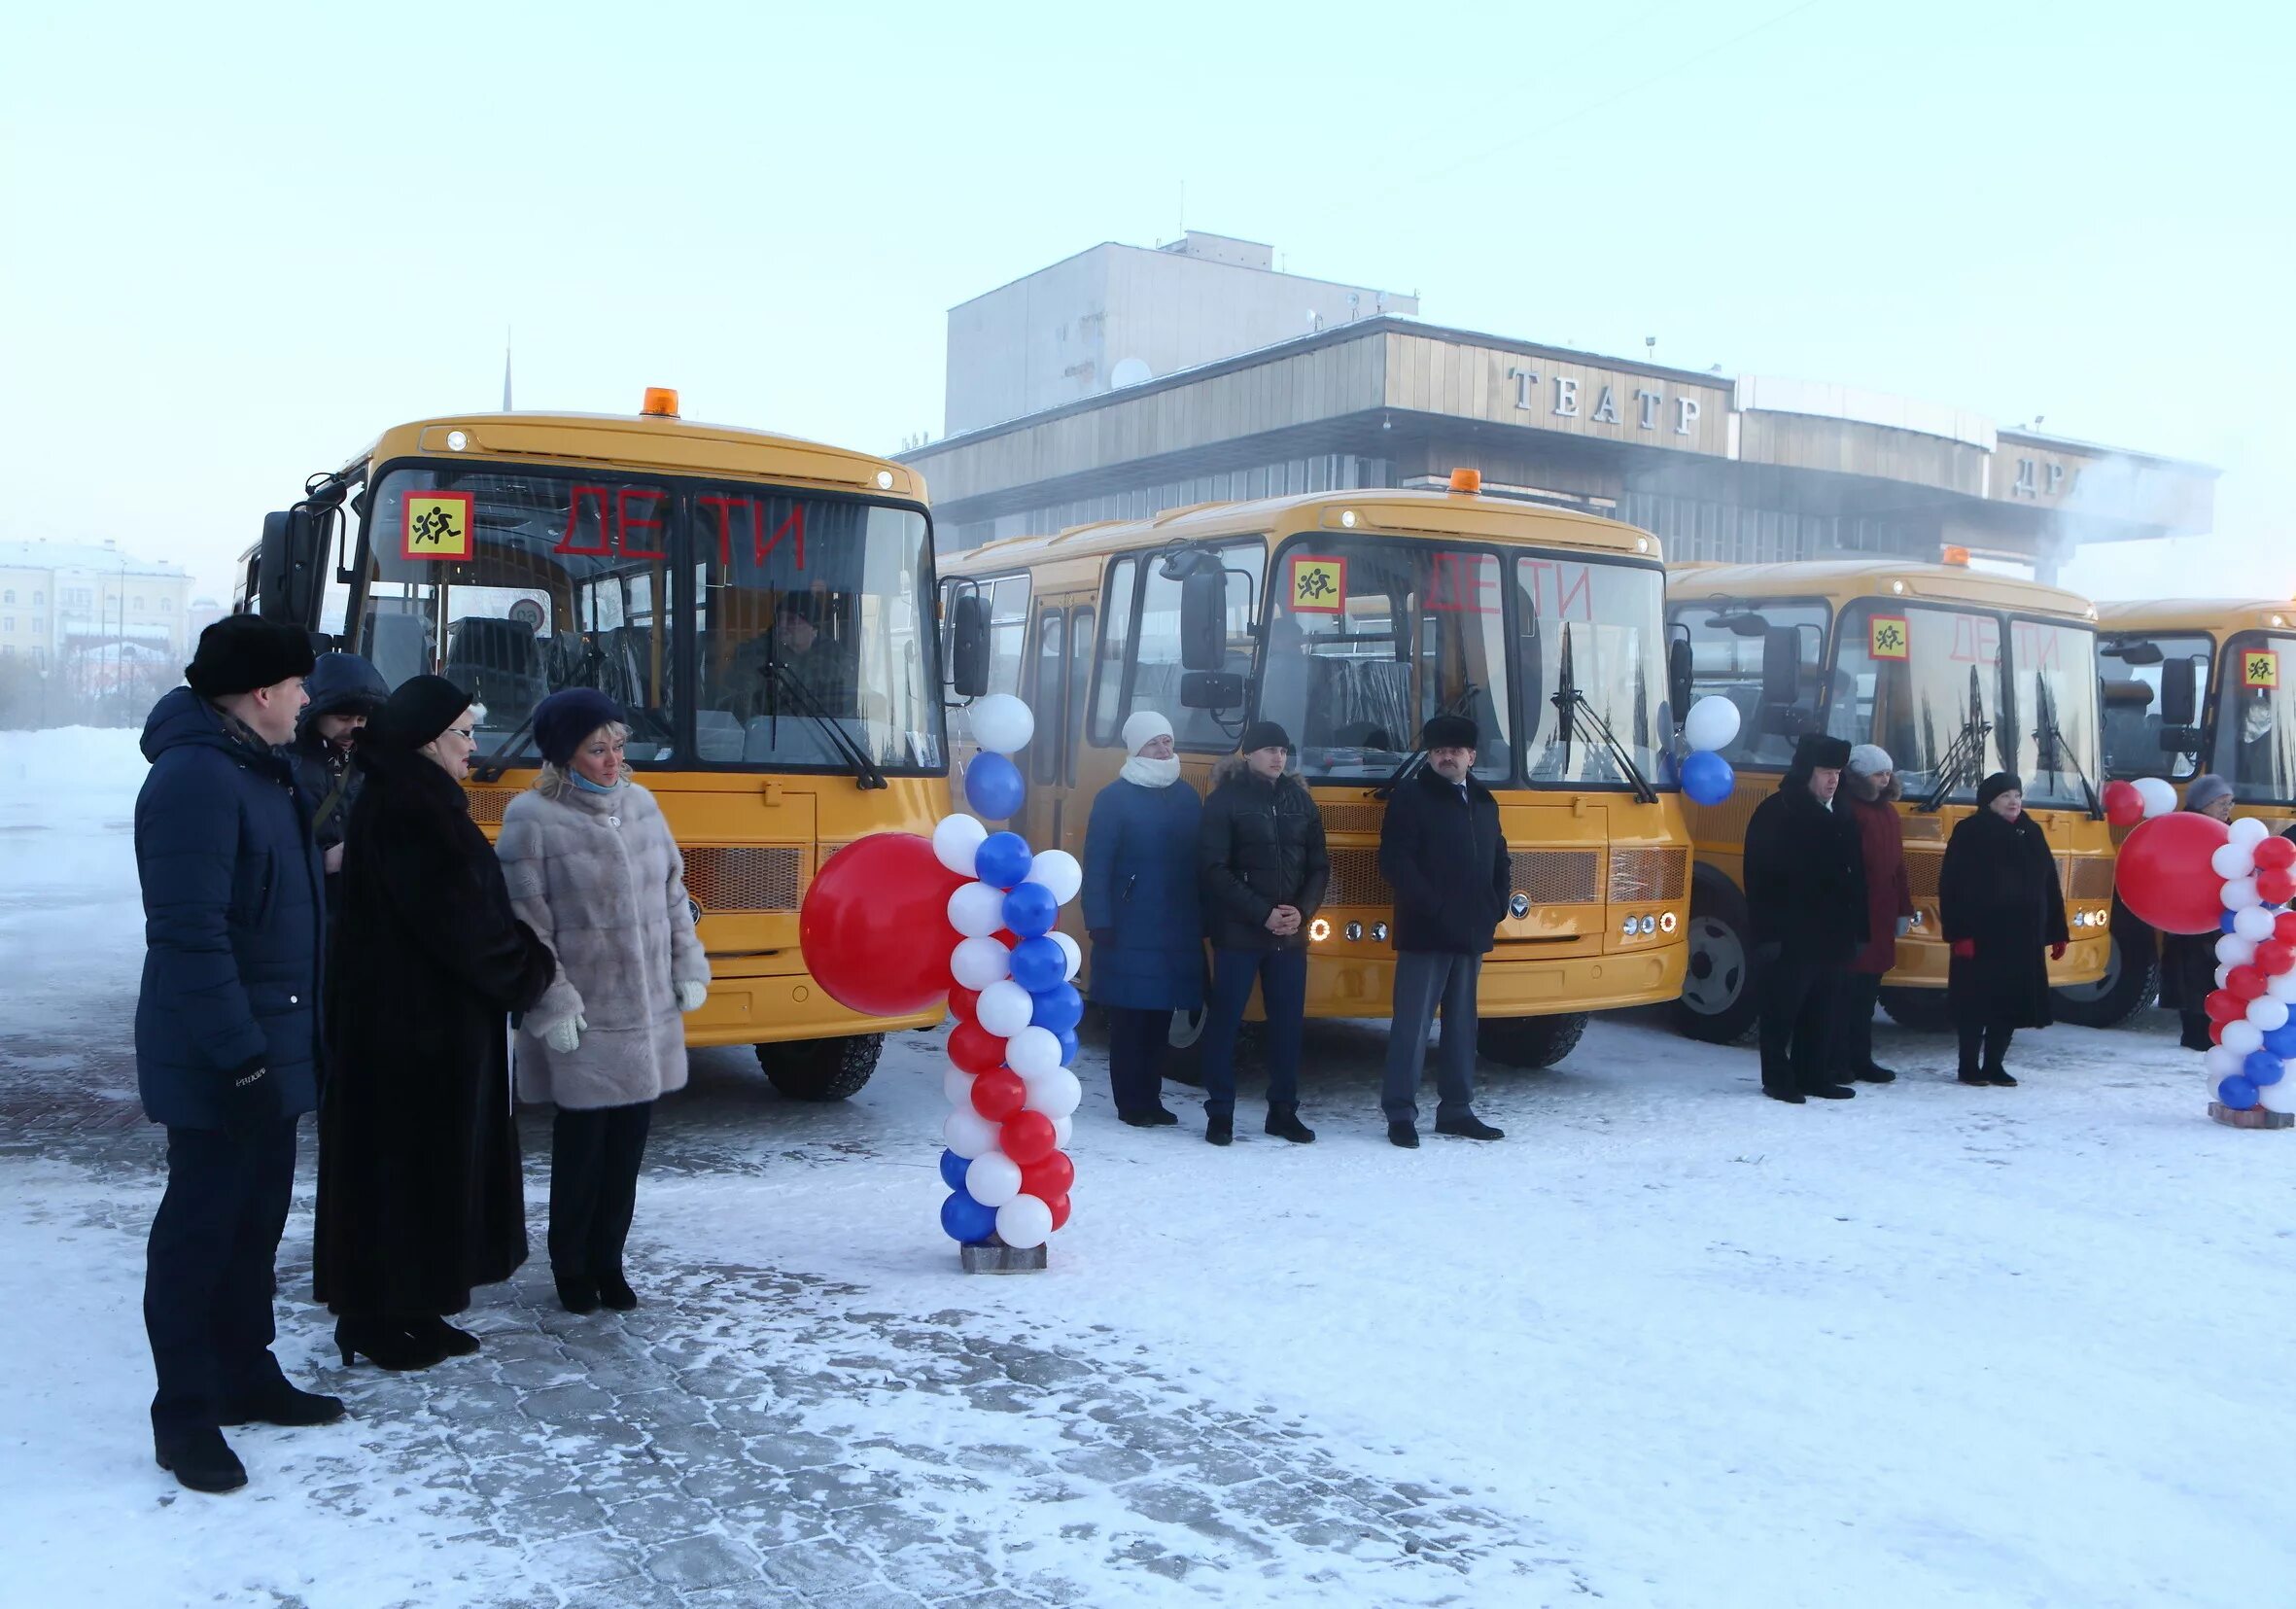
xmin=797 ymin=833 xmax=964 ymax=1017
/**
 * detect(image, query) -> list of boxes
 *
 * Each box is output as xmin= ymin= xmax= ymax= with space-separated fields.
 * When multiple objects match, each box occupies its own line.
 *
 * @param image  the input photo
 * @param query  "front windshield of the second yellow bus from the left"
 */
xmin=1261 ymin=535 xmax=1672 ymax=787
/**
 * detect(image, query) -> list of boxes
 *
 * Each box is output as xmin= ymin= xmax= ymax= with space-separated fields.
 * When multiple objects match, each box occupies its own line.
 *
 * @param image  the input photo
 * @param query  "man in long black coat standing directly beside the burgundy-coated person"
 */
xmin=1745 ymin=732 xmax=1866 ymax=1104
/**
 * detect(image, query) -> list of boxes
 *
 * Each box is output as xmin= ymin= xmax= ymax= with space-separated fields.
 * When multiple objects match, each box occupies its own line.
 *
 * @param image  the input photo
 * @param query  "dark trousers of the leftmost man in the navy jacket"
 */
xmin=145 ymin=1118 xmax=294 ymax=1435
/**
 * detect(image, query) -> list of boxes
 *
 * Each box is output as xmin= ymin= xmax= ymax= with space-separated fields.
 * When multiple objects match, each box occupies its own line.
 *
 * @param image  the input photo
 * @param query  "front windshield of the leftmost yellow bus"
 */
xmin=358 ymin=466 xmax=944 ymax=774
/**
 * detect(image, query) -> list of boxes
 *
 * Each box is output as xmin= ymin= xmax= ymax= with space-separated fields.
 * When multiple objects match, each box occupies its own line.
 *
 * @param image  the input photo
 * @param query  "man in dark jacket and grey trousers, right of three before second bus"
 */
xmin=1380 ymin=717 xmax=1513 ymax=1150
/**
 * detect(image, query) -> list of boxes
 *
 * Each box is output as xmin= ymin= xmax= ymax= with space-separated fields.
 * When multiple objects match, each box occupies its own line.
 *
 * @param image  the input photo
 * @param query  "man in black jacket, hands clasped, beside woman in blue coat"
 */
xmin=1197 ymin=720 xmax=1332 ymax=1145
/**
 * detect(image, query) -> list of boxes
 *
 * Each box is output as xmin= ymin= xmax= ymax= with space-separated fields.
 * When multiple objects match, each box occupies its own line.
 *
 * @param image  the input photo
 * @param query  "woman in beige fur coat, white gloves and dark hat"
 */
xmin=496 ymin=686 xmax=710 ymax=1312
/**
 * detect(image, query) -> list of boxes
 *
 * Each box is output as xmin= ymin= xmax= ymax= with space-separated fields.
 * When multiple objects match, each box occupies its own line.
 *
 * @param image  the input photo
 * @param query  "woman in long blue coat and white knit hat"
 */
xmin=1084 ymin=710 xmax=1203 ymax=1130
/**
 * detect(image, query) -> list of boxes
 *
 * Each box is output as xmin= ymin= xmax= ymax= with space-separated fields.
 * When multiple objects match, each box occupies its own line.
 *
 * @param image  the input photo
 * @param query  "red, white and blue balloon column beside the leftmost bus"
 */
xmin=932 ymin=693 xmax=1084 ymax=1251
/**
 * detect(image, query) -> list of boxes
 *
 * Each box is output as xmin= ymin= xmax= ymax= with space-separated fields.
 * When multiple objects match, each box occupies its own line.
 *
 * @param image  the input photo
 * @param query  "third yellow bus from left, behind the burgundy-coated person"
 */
xmin=1667 ymin=560 xmax=2112 ymax=1042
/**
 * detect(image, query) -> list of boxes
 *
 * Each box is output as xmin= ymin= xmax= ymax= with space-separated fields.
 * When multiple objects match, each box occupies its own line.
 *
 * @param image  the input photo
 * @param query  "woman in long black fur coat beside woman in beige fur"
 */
xmin=315 ymin=677 xmax=556 ymax=1368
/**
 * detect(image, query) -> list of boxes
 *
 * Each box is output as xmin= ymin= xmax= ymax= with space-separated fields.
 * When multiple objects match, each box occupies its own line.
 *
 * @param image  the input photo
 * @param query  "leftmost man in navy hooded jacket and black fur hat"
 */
xmin=135 ymin=615 xmax=342 ymax=1492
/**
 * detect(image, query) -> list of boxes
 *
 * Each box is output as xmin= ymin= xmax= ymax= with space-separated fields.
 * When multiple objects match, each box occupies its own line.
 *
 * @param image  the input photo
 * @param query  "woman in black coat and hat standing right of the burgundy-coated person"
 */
xmin=1938 ymin=771 xmax=2071 ymax=1086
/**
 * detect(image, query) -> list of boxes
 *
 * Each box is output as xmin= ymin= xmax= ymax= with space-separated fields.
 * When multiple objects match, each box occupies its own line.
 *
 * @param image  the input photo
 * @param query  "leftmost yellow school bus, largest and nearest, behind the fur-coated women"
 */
xmin=243 ymin=390 xmax=949 ymax=1100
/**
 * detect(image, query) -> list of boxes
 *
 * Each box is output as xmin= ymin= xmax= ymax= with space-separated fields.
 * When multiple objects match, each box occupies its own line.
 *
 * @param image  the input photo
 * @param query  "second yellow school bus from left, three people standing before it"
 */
xmin=941 ymin=472 xmax=1689 ymax=1067
